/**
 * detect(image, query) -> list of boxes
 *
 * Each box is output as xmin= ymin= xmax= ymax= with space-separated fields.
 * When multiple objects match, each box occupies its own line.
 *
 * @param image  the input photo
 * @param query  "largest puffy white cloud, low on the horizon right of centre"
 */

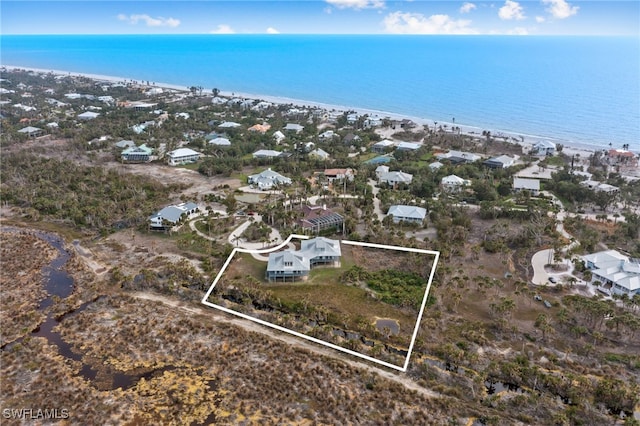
xmin=383 ymin=12 xmax=478 ymax=34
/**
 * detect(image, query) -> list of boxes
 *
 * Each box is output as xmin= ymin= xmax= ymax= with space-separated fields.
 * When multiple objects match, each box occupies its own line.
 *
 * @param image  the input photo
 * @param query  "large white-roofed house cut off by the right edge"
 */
xmin=582 ymin=250 xmax=640 ymax=297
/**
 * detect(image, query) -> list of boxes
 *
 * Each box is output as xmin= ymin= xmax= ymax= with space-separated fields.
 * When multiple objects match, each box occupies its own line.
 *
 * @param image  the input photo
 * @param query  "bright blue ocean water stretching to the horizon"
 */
xmin=0 ymin=35 xmax=640 ymax=151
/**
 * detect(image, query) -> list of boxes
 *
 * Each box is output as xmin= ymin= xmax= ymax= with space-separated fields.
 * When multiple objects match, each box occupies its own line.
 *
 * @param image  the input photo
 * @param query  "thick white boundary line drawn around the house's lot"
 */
xmin=202 ymin=234 xmax=440 ymax=373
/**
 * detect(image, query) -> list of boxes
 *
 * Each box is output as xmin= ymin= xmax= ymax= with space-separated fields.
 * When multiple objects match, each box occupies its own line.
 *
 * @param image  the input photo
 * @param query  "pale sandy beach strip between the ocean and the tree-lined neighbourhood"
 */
xmin=2 ymin=65 xmax=607 ymax=156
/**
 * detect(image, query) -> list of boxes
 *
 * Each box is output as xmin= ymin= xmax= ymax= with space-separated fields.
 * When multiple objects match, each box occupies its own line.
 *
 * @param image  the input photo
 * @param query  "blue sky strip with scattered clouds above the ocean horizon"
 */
xmin=0 ymin=0 xmax=640 ymax=38
